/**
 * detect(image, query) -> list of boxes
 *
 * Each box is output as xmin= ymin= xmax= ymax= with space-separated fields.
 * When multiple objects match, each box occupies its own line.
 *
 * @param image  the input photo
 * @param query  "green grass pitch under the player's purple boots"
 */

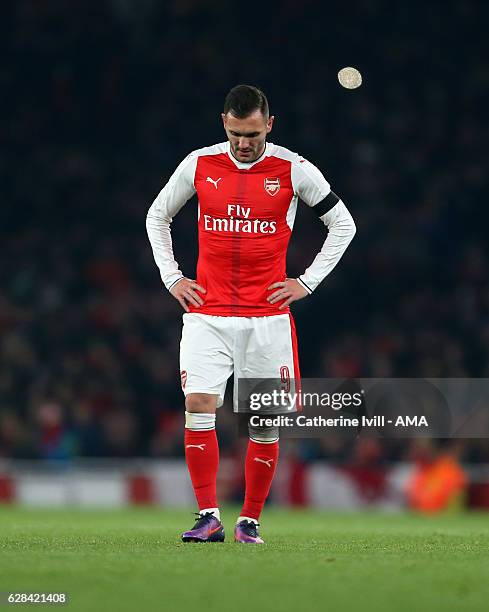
xmin=0 ymin=507 xmax=489 ymax=612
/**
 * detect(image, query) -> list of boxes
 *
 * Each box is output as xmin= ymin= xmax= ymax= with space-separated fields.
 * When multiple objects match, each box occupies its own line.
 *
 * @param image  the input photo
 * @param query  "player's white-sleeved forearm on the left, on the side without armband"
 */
xmin=146 ymin=206 xmax=183 ymax=290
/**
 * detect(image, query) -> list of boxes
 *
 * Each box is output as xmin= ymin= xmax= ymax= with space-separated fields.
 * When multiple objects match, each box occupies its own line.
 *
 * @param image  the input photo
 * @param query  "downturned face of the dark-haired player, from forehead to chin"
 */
xmin=221 ymin=110 xmax=274 ymax=162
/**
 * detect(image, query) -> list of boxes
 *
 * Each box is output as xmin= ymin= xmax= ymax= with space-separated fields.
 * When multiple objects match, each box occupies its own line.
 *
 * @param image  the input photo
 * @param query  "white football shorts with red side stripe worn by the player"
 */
xmin=180 ymin=312 xmax=300 ymax=411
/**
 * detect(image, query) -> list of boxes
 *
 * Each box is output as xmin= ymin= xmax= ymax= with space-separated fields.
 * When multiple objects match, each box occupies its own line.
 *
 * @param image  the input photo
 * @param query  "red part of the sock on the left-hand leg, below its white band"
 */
xmin=185 ymin=429 xmax=219 ymax=510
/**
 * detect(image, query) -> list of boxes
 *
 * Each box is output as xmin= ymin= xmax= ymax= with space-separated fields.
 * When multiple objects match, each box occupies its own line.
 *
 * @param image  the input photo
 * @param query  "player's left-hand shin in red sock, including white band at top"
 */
xmin=185 ymin=412 xmax=220 ymax=519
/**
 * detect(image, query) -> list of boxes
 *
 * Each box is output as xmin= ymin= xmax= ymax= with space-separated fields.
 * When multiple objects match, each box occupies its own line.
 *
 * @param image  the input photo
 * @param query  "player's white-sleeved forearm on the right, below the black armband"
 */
xmin=299 ymin=200 xmax=356 ymax=293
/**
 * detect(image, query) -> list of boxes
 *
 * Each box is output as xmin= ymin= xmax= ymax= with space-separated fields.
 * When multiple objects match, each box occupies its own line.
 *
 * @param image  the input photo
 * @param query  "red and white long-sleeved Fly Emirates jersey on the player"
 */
xmin=147 ymin=142 xmax=355 ymax=317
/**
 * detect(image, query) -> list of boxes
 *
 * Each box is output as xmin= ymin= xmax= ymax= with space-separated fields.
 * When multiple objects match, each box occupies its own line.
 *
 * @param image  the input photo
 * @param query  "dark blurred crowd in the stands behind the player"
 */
xmin=0 ymin=0 xmax=489 ymax=462
